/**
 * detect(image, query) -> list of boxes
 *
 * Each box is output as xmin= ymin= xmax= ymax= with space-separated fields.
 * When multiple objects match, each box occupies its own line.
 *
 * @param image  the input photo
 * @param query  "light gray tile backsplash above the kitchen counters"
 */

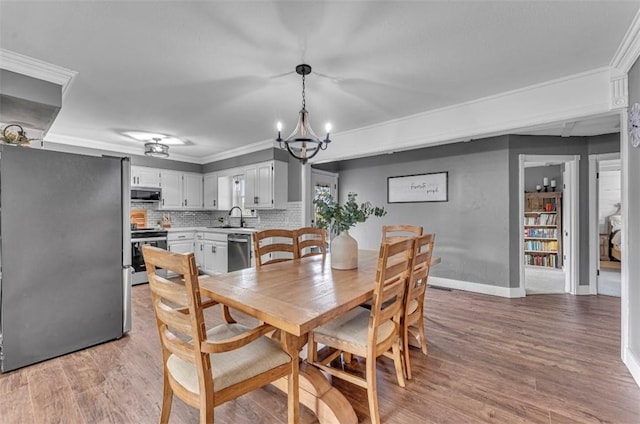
xmin=131 ymin=202 xmax=302 ymax=230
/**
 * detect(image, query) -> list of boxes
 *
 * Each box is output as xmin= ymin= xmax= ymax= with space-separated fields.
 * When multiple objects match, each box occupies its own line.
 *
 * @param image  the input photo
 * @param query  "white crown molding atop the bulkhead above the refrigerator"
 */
xmin=0 ymin=49 xmax=78 ymax=99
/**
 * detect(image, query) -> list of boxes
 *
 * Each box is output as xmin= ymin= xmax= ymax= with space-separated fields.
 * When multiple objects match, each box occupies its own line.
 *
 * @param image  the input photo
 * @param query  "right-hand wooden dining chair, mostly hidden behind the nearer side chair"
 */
xmin=402 ymin=234 xmax=436 ymax=379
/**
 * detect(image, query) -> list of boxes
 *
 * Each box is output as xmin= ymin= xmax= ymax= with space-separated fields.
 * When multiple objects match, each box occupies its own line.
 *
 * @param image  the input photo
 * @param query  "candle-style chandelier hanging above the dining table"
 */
xmin=276 ymin=64 xmax=331 ymax=164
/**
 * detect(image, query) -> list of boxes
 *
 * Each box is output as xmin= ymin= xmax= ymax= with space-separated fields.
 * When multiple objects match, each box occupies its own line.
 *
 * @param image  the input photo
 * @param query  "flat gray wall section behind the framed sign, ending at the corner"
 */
xmin=338 ymin=136 xmax=510 ymax=287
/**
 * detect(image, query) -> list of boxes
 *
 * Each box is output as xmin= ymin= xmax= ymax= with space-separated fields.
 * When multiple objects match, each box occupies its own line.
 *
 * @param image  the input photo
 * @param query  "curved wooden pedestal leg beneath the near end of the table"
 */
xmin=273 ymin=362 xmax=358 ymax=424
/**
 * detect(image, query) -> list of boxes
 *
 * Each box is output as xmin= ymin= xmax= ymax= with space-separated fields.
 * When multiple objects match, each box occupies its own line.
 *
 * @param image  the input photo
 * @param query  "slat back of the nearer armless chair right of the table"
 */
xmin=367 ymin=239 xmax=414 ymax=346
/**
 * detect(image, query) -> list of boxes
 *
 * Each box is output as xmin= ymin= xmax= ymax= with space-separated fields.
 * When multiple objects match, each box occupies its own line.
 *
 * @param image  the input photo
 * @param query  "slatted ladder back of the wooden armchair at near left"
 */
xmin=142 ymin=245 xmax=213 ymax=374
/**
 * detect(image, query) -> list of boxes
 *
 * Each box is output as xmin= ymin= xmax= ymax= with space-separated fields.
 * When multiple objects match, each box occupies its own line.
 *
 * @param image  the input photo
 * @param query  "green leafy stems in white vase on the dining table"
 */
xmin=313 ymin=193 xmax=387 ymax=269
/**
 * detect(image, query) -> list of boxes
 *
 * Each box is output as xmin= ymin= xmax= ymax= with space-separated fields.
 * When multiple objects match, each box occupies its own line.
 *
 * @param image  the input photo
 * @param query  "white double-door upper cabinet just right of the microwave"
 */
xmin=160 ymin=170 xmax=202 ymax=210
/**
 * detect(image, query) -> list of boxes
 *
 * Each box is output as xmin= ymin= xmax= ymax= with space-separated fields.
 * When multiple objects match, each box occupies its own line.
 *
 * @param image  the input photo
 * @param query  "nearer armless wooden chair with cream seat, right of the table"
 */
xmin=307 ymin=239 xmax=414 ymax=423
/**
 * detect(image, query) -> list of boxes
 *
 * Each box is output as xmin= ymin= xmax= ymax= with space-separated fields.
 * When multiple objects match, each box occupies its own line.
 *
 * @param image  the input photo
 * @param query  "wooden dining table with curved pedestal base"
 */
xmin=199 ymin=250 xmax=440 ymax=424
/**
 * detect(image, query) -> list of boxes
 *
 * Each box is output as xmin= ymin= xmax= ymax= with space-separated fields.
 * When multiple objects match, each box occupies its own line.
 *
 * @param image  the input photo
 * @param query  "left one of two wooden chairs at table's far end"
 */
xmin=253 ymin=229 xmax=298 ymax=268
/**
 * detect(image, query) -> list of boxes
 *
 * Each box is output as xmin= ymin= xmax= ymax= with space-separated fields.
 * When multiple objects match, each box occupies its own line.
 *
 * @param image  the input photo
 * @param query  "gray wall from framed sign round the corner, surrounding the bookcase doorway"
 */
xmin=330 ymin=134 xmax=620 ymax=287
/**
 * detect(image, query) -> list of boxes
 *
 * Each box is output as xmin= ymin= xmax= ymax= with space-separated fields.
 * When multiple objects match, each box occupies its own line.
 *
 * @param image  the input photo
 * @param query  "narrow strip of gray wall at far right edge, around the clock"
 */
xmin=627 ymin=60 xmax=640 ymax=360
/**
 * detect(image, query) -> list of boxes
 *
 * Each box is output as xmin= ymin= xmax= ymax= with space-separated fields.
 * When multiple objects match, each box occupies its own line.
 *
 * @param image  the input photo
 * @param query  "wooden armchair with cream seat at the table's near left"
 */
xmin=142 ymin=246 xmax=299 ymax=424
